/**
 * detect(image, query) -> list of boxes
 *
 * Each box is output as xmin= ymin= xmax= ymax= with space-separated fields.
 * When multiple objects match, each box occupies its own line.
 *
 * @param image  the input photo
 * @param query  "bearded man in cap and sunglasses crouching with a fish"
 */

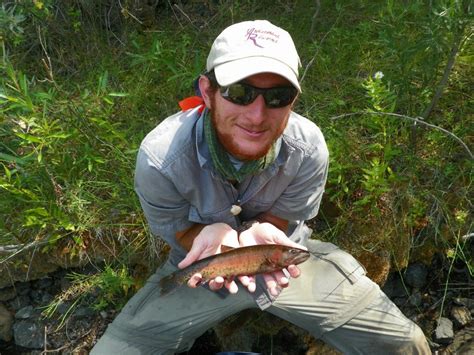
xmin=92 ymin=21 xmax=430 ymax=354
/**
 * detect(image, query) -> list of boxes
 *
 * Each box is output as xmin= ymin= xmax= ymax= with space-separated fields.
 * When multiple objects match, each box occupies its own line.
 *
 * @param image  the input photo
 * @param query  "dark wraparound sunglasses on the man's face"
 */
xmin=219 ymin=82 xmax=298 ymax=108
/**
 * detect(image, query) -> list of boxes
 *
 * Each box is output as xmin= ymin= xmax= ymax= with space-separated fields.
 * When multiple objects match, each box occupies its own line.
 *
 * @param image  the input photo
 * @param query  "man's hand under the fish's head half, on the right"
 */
xmin=239 ymin=222 xmax=305 ymax=296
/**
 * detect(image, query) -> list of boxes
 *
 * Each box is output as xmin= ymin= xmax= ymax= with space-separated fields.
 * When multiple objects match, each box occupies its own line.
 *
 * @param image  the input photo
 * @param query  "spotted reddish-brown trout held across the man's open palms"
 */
xmin=159 ymin=244 xmax=309 ymax=295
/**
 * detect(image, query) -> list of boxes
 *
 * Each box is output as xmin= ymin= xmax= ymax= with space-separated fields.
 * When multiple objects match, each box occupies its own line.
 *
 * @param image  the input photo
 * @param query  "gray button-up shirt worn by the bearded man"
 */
xmin=135 ymin=108 xmax=328 ymax=264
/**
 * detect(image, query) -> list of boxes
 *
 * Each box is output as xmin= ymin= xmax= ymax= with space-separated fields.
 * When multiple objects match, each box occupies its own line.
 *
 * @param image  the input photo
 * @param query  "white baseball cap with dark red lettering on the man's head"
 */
xmin=206 ymin=20 xmax=301 ymax=92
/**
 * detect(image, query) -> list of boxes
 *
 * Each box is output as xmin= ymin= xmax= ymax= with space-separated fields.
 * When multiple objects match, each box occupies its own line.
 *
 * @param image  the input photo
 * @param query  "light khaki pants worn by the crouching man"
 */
xmin=91 ymin=241 xmax=431 ymax=355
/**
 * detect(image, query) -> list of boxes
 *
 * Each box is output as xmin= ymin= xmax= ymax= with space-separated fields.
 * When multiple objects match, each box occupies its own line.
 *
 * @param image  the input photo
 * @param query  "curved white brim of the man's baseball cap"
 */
xmin=214 ymin=56 xmax=301 ymax=92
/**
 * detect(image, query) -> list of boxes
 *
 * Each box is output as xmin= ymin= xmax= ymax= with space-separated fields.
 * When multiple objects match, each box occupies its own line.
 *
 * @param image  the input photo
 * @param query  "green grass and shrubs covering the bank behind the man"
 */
xmin=0 ymin=0 xmax=474 ymax=316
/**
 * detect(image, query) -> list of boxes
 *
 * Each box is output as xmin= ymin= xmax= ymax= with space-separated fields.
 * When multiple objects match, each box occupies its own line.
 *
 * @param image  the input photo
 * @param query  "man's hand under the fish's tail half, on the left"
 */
xmin=178 ymin=223 xmax=244 ymax=293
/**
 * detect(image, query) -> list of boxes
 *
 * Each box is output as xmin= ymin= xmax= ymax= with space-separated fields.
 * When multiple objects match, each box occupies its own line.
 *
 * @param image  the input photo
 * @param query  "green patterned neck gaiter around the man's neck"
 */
xmin=203 ymin=109 xmax=276 ymax=183
